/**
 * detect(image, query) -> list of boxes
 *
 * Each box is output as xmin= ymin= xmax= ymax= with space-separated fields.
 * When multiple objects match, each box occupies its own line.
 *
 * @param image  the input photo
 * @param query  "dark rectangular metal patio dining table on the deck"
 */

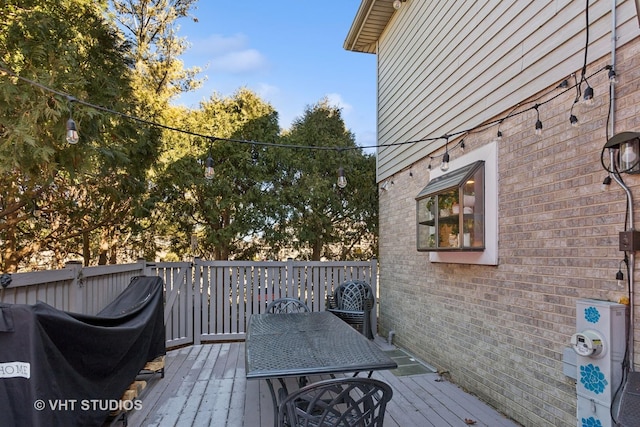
xmin=245 ymin=311 xmax=398 ymax=426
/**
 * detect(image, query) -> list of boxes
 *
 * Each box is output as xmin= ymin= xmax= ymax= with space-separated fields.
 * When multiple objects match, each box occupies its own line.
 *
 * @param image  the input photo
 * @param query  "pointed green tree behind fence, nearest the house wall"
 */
xmin=264 ymin=99 xmax=378 ymax=260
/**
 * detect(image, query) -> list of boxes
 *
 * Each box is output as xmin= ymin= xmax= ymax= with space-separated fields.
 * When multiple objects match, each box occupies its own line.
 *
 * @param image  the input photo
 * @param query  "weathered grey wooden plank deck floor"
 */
xmin=110 ymin=342 xmax=519 ymax=427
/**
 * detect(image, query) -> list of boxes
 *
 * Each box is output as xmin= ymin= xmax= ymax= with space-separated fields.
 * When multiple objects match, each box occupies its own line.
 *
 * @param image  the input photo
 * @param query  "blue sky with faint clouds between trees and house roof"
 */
xmin=175 ymin=0 xmax=376 ymax=151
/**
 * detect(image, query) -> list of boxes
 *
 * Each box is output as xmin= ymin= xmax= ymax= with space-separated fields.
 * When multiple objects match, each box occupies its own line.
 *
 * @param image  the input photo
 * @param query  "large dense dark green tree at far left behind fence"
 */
xmin=0 ymin=0 xmax=156 ymax=271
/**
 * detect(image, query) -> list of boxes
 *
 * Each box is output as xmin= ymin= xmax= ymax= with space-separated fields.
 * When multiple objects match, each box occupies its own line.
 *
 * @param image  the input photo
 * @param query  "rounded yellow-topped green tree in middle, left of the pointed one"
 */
xmin=151 ymin=89 xmax=279 ymax=259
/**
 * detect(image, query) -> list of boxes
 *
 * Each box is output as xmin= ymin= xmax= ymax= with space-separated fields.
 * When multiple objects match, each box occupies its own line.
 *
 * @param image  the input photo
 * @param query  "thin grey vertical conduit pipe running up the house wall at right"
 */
xmin=608 ymin=0 xmax=636 ymax=371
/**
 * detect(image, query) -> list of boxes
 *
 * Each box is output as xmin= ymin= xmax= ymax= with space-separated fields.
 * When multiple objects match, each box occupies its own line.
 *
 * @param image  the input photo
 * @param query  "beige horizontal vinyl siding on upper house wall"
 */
xmin=377 ymin=0 xmax=639 ymax=181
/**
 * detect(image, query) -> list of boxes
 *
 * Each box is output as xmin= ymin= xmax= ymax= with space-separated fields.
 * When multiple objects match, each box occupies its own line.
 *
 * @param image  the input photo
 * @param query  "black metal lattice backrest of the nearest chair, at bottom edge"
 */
xmin=278 ymin=377 xmax=393 ymax=427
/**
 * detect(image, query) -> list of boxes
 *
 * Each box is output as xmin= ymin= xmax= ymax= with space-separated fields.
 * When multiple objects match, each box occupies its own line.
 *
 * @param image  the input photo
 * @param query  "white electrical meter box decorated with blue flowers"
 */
xmin=571 ymin=299 xmax=627 ymax=427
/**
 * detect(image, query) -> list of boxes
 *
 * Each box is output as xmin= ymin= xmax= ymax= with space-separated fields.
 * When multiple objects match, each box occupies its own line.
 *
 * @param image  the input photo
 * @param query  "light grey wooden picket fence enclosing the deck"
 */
xmin=0 ymin=259 xmax=377 ymax=347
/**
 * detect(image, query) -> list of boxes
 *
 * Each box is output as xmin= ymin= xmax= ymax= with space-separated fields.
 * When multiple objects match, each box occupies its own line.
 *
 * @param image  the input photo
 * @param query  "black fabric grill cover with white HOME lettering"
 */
xmin=0 ymin=277 xmax=166 ymax=427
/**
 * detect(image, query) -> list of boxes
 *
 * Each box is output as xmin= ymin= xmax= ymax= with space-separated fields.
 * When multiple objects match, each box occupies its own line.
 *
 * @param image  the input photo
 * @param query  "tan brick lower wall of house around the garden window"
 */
xmin=379 ymin=41 xmax=640 ymax=427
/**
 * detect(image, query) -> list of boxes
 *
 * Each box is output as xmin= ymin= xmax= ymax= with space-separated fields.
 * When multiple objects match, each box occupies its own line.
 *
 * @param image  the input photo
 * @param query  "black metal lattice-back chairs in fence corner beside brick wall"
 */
xmin=326 ymin=280 xmax=376 ymax=339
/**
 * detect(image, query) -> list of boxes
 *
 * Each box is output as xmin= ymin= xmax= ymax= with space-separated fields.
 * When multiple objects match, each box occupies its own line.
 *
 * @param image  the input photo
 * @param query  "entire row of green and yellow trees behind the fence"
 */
xmin=0 ymin=0 xmax=377 ymax=271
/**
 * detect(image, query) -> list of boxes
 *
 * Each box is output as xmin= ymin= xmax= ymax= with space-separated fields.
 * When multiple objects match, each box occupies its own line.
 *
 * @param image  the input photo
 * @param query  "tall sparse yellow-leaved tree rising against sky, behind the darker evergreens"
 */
xmin=107 ymin=0 xmax=201 ymax=259
